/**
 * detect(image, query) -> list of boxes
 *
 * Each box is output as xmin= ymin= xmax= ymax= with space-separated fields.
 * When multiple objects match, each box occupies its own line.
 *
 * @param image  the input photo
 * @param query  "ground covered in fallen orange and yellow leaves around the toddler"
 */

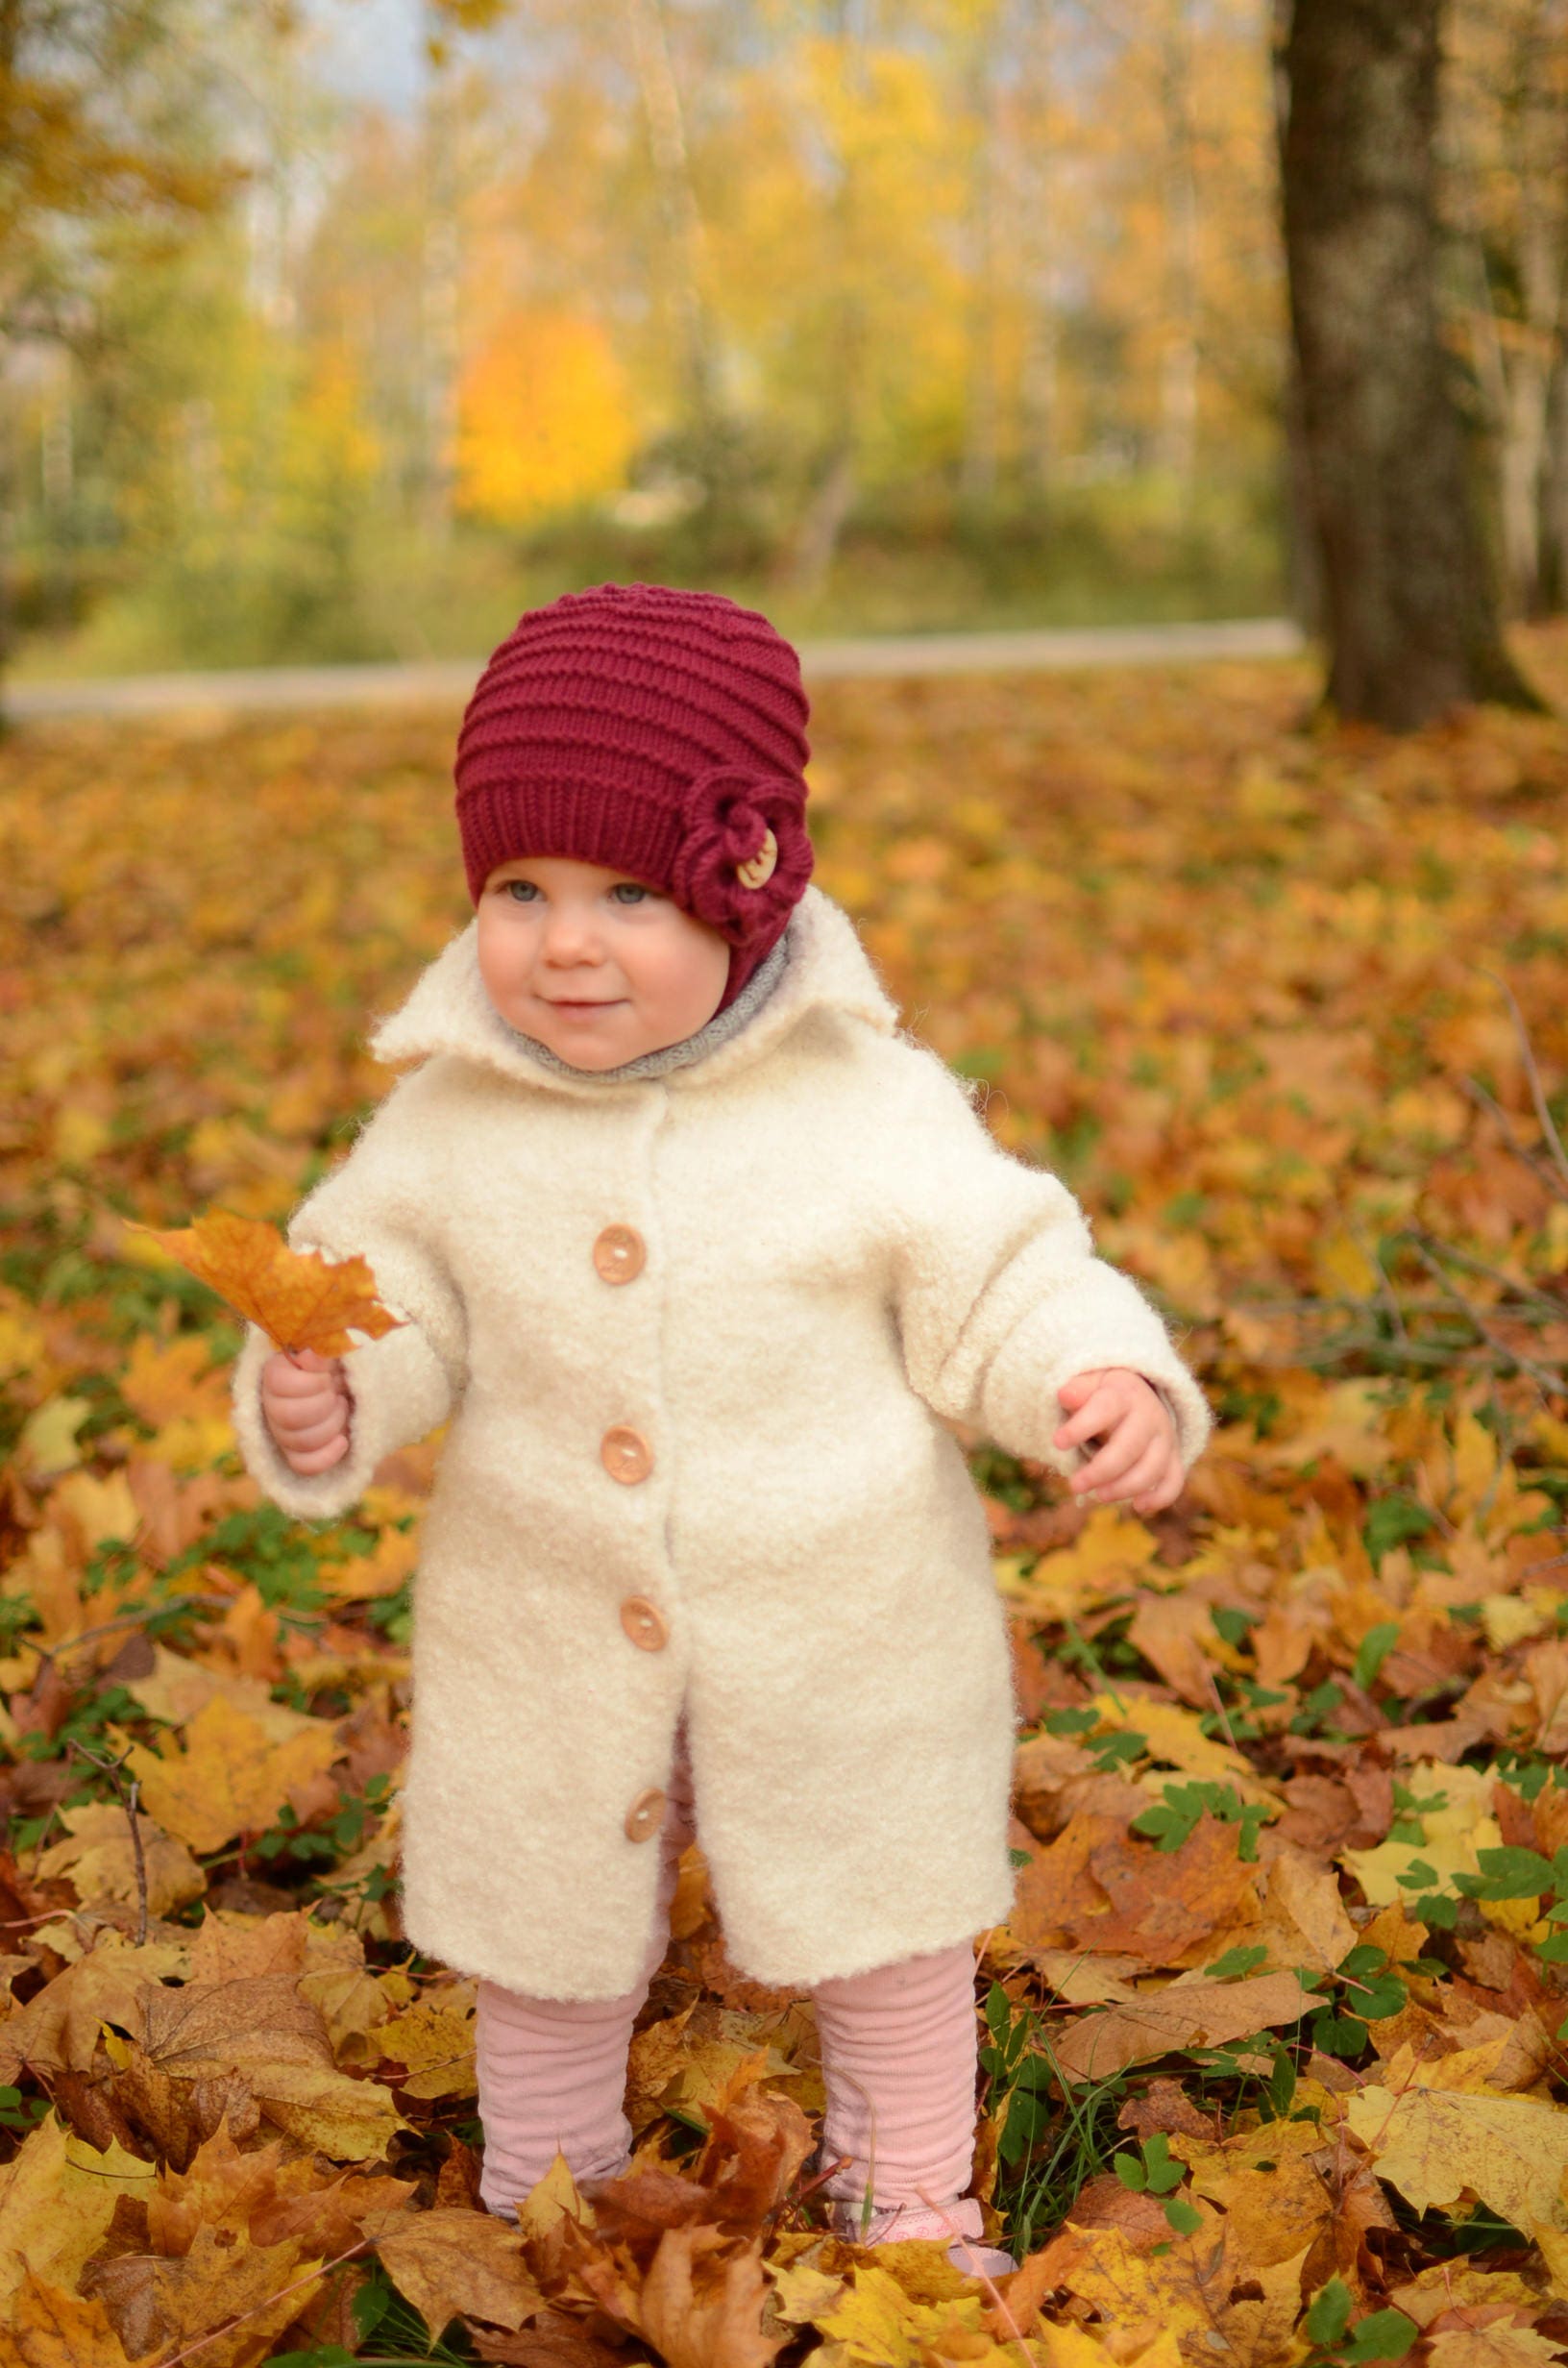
xmin=0 ymin=629 xmax=1568 ymax=2368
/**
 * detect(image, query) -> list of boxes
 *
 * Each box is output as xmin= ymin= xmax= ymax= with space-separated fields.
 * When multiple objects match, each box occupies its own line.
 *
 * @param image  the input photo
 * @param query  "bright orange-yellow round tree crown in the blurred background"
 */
xmin=457 ymin=308 xmax=637 ymax=526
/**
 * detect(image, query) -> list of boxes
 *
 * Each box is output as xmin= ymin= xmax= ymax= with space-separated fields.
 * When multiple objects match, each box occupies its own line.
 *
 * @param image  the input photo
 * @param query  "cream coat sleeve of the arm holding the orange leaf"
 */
xmin=233 ymin=1073 xmax=467 ymax=1520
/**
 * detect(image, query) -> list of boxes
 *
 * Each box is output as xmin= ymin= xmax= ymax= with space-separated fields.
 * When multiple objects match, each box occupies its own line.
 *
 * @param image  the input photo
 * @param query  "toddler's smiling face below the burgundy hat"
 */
xmin=478 ymin=855 xmax=729 ymax=1068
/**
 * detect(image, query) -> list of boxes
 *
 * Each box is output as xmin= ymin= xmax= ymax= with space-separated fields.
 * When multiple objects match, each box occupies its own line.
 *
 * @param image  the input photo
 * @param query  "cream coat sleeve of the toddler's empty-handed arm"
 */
xmin=893 ymin=1042 xmax=1211 ymax=1473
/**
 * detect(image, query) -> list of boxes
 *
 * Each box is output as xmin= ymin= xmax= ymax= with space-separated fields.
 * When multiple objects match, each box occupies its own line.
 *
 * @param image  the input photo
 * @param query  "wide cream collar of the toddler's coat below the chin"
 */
xmin=370 ymin=888 xmax=897 ymax=1098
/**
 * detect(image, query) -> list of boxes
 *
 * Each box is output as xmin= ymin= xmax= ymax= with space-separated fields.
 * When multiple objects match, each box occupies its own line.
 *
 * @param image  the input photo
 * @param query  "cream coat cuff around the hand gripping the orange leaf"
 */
xmin=233 ymin=1321 xmax=453 ymax=1520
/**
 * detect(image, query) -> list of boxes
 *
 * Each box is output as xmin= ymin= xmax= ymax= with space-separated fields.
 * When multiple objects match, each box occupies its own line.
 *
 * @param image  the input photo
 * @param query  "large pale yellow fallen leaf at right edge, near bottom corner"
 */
xmin=1345 ymin=2065 xmax=1568 ymax=2229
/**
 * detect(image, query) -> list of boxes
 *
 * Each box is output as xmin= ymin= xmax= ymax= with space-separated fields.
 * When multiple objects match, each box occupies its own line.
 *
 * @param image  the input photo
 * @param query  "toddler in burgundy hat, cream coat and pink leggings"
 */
xmin=234 ymin=585 xmax=1208 ymax=2269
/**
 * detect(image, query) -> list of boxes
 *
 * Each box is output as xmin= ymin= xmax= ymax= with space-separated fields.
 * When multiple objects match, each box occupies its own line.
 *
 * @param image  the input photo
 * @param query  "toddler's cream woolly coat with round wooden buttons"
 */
xmin=234 ymin=888 xmax=1208 ymax=1999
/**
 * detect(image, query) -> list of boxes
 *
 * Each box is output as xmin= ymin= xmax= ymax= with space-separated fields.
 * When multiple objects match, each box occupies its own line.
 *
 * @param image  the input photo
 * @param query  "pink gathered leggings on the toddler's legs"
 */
xmin=477 ymin=1739 xmax=981 ymax=2242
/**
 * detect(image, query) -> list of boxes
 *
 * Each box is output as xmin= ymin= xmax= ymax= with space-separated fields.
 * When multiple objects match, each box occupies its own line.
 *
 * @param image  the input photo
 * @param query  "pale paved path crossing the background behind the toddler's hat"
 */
xmin=0 ymin=616 xmax=1303 ymax=723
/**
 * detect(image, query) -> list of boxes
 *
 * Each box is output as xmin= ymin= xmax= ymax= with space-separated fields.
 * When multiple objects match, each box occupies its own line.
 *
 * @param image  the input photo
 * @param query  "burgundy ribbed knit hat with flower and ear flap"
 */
xmin=454 ymin=585 xmax=813 ymax=1011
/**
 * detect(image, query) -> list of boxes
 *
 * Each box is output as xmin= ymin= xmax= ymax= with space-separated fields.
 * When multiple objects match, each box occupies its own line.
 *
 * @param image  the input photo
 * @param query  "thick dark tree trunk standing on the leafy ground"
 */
xmin=1282 ymin=0 xmax=1539 ymax=731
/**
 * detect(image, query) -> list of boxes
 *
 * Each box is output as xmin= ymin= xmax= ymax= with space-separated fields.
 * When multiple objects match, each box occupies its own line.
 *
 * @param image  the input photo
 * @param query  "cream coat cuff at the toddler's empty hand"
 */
xmin=981 ymin=1260 xmax=1213 ymax=1473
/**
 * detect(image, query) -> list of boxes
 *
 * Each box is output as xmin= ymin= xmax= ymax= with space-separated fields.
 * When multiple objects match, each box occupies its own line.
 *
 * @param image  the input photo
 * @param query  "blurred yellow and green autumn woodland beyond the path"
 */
xmin=0 ymin=0 xmax=1568 ymax=691
